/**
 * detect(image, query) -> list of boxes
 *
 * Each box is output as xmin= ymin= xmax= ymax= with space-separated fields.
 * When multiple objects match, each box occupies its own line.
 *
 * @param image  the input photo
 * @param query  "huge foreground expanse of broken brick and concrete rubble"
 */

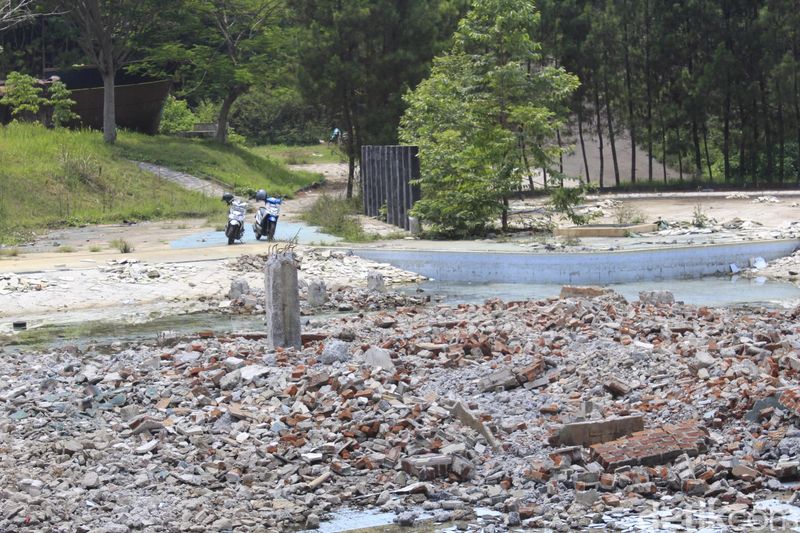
xmin=0 ymin=288 xmax=800 ymax=531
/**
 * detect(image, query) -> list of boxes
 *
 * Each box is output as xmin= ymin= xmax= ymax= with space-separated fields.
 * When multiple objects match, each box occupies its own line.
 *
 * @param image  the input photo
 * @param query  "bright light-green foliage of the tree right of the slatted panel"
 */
xmin=400 ymin=0 xmax=578 ymax=234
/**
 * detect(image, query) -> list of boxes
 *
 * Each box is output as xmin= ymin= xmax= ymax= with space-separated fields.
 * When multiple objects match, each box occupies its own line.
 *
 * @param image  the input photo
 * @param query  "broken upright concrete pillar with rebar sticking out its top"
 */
xmin=264 ymin=252 xmax=301 ymax=349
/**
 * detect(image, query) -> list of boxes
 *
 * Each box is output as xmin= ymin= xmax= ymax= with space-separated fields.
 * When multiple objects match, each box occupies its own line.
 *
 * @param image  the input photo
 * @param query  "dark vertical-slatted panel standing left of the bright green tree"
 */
xmin=361 ymin=146 xmax=420 ymax=230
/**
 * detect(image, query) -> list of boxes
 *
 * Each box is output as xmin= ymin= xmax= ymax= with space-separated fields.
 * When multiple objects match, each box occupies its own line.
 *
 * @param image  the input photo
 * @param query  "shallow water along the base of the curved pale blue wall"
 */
xmin=404 ymin=277 xmax=800 ymax=307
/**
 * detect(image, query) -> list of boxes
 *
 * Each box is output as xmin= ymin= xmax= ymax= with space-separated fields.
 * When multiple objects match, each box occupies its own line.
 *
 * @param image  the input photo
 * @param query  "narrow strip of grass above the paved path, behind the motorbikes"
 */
xmin=114 ymin=132 xmax=321 ymax=195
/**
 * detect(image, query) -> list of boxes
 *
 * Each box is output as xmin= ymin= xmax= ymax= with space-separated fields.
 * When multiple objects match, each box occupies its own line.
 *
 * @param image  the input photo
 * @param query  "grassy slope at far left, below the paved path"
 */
xmin=0 ymin=123 xmax=220 ymax=243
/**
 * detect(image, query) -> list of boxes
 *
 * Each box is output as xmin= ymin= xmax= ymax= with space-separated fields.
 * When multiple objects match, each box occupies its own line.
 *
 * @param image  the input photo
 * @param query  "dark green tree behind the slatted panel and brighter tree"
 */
xmin=292 ymin=0 xmax=467 ymax=197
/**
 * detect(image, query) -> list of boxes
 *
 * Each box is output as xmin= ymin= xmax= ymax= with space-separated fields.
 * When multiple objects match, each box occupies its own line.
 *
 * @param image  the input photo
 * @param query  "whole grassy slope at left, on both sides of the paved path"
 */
xmin=0 ymin=124 xmax=318 ymax=243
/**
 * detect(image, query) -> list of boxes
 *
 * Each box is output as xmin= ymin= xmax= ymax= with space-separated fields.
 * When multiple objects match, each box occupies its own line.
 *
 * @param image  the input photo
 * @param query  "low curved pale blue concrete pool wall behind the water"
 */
xmin=352 ymin=240 xmax=800 ymax=285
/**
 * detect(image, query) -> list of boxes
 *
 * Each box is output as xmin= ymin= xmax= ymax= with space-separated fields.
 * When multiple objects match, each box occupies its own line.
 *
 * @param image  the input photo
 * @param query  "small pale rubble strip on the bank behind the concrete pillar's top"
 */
xmin=229 ymin=248 xmax=426 ymax=286
